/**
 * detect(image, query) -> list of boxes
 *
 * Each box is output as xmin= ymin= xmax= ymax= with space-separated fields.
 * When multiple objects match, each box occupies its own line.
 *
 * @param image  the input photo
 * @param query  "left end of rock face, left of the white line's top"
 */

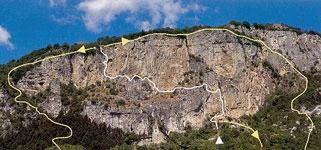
xmin=17 ymin=54 xmax=104 ymax=95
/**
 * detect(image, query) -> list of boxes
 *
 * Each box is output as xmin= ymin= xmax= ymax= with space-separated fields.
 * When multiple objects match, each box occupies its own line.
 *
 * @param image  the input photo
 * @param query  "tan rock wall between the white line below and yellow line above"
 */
xmin=103 ymin=31 xmax=297 ymax=120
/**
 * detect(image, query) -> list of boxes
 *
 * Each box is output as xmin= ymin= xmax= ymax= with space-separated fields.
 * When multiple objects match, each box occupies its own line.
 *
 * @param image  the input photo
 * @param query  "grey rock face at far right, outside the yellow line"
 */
xmin=239 ymin=25 xmax=321 ymax=72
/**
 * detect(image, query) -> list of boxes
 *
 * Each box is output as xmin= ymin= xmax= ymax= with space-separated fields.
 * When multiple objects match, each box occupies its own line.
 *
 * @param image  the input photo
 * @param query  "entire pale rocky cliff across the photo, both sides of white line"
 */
xmin=0 ymin=26 xmax=321 ymax=142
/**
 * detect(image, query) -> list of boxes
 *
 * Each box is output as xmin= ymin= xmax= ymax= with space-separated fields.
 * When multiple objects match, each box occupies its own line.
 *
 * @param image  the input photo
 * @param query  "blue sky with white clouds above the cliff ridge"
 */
xmin=0 ymin=0 xmax=321 ymax=64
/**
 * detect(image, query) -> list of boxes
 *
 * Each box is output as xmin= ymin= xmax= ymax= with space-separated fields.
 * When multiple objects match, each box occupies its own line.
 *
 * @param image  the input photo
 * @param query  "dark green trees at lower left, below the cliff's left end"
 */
xmin=0 ymin=84 xmax=139 ymax=150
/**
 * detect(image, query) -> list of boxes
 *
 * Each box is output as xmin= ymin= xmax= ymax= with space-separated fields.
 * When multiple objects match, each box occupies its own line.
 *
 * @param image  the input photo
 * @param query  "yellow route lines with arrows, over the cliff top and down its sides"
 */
xmin=8 ymin=28 xmax=314 ymax=150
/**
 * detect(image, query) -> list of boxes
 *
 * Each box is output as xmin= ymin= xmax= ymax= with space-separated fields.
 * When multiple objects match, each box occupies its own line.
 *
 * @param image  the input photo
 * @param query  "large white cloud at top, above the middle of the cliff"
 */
xmin=78 ymin=0 xmax=202 ymax=32
